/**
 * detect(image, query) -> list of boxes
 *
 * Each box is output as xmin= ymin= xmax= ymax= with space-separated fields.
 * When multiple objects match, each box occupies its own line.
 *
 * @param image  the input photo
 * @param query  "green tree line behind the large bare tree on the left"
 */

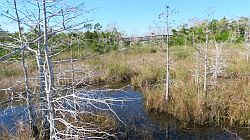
xmin=0 ymin=23 xmax=122 ymax=58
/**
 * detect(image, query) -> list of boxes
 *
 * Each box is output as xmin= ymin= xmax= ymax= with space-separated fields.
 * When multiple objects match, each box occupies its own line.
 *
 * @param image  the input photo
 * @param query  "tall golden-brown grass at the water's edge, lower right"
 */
xmin=143 ymin=74 xmax=250 ymax=125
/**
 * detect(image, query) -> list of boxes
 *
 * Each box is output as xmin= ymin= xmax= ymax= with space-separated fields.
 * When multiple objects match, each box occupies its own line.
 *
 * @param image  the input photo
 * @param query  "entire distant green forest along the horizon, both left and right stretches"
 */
xmin=0 ymin=17 xmax=250 ymax=56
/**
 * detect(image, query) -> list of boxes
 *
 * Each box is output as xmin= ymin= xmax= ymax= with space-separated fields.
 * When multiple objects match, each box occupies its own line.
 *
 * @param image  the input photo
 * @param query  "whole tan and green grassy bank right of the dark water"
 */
xmin=84 ymin=43 xmax=250 ymax=125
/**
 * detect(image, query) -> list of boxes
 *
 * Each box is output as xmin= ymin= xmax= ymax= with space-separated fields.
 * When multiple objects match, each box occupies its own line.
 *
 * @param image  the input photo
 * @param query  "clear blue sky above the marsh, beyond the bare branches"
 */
xmin=0 ymin=0 xmax=250 ymax=36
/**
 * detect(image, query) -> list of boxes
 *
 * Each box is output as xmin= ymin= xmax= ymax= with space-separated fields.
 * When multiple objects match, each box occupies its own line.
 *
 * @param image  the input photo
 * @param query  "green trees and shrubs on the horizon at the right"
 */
xmin=169 ymin=17 xmax=249 ymax=46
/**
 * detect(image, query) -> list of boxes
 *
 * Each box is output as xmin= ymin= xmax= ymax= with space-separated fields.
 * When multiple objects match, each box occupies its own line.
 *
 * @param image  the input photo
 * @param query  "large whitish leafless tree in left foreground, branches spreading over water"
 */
xmin=0 ymin=0 xmax=124 ymax=140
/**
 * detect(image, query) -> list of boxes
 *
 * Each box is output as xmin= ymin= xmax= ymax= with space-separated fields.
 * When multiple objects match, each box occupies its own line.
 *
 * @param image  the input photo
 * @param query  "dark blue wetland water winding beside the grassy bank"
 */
xmin=0 ymin=87 xmax=250 ymax=140
